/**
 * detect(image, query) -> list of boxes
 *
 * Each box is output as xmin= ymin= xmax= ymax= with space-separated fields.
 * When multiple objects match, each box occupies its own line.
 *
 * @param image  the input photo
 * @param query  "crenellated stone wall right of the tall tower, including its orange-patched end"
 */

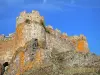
xmin=46 ymin=25 xmax=89 ymax=53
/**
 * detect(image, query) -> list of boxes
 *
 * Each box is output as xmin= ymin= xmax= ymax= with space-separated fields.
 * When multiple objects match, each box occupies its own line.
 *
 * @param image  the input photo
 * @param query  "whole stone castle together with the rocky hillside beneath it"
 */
xmin=0 ymin=11 xmax=100 ymax=75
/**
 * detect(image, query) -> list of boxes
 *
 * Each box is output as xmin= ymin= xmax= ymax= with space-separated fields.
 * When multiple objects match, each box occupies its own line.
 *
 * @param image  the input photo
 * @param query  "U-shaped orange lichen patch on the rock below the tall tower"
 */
xmin=16 ymin=50 xmax=42 ymax=75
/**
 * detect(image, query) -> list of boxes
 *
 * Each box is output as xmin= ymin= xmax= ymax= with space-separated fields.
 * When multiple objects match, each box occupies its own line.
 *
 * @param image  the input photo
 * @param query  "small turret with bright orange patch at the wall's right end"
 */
xmin=69 ymin=34 xmax=89 ymax=53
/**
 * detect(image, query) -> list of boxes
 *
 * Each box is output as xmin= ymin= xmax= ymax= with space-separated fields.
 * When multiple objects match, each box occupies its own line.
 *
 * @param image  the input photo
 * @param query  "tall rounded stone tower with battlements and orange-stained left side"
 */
xmin=16 ymin=11 xmax=46 ymax=47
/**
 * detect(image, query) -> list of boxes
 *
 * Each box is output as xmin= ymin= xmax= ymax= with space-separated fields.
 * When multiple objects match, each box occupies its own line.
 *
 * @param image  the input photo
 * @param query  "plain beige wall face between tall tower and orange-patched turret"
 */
xmin=46 ymin=33 xmax=75 ymax=52
